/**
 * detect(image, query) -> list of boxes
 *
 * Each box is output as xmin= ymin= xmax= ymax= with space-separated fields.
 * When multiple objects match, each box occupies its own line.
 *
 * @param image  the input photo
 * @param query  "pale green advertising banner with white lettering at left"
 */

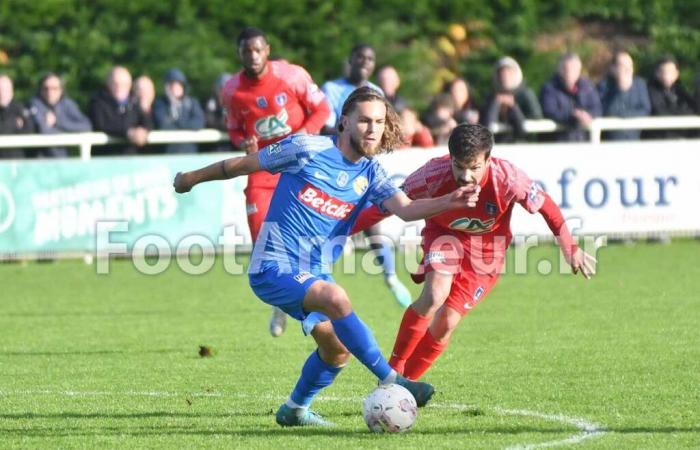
xmin=0 ymin=154 xmax=250 ymax=256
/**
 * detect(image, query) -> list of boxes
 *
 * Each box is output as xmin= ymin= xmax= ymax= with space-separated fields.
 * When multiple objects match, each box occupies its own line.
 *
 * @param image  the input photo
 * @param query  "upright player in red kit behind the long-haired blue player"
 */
xmin=221 ymin=27 xmax=330 ymax=336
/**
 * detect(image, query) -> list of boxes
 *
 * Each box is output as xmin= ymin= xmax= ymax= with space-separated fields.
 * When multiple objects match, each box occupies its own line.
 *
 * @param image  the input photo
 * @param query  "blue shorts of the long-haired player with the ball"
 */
xmin=248 ymin=262 xmax=335 ymax=335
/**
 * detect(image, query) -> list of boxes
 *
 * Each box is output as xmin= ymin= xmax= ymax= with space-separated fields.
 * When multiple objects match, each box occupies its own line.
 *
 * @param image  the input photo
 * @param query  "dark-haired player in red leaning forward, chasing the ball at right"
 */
xmin=353 ymin=124 xmax=596 ymax=380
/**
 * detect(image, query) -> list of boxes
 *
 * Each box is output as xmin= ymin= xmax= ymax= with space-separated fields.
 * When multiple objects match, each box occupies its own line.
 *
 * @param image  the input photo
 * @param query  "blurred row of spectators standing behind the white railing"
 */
xmin=0 ymin=45 xmax=700 ymax=158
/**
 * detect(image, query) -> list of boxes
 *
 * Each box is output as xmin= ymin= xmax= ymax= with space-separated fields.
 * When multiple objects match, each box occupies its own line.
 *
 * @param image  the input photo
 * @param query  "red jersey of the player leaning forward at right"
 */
xmin=403 ymin=155 xmax=546 ymax=256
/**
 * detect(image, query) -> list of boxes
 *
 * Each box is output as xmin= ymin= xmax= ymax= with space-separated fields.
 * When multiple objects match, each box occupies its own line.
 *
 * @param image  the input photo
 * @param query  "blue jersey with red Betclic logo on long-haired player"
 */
xmin=250 ymin=135 xmax=398 ymax=273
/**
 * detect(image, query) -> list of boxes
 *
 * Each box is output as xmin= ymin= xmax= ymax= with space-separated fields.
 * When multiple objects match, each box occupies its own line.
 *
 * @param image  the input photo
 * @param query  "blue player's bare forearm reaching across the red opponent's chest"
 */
xmin=383 ymin=185 xmax=480 ymax=222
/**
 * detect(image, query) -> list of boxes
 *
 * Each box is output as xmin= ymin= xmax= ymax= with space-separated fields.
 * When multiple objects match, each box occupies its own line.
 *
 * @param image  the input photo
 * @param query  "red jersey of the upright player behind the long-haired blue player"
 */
xmin=222 ymin=61 xmax=330 ymax=189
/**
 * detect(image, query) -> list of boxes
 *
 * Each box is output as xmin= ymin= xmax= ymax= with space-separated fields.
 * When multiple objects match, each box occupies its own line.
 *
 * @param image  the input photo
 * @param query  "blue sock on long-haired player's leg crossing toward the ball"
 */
xmin=331 ymin=311 xmax=393 ymax=380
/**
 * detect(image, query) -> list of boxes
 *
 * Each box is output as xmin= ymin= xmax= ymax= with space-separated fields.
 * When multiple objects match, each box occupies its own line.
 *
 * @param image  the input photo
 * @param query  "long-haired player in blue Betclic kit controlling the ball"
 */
xmin=173 ymin=87 xmax=478 ymax=426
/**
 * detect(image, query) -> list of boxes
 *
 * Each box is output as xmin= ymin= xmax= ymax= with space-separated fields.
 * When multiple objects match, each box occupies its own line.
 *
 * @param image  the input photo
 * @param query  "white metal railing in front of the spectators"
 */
xmin=0 ymin=116 xmax=700 ymax=159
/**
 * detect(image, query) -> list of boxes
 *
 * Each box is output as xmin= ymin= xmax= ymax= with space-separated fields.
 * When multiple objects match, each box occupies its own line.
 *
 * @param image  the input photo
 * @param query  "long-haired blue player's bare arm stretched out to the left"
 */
xmin=173 ymin=153 xmax=260 ymax=194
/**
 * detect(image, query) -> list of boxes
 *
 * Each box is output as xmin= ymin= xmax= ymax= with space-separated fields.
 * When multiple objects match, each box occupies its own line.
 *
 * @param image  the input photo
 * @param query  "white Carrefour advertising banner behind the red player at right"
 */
xmin=383 ymin=140 xmax=700 ymax=236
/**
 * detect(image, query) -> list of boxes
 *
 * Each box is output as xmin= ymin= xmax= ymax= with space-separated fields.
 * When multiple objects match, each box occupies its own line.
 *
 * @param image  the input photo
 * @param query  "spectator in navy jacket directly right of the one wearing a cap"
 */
xmin=540 ymin=53 xmax=603 ymax=141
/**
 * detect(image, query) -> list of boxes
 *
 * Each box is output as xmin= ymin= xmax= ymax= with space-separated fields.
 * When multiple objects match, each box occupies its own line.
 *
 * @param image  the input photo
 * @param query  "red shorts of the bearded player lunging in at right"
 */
xmin=412 ymin=229 xmax=505 ymax=316
